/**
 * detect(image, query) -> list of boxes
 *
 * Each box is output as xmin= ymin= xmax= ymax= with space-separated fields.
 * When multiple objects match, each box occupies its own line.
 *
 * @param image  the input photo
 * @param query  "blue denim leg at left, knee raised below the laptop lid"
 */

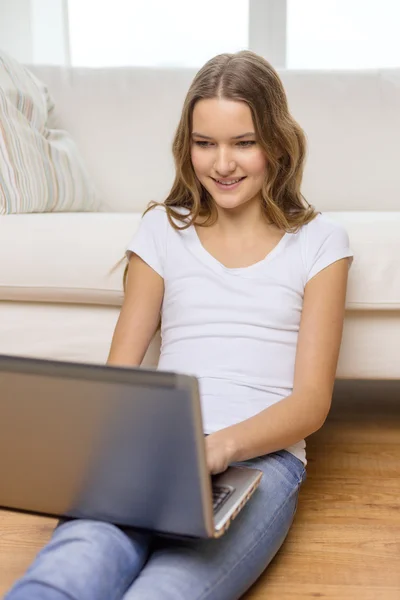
xmin=5 ymin=519 xmax=151 ymax=600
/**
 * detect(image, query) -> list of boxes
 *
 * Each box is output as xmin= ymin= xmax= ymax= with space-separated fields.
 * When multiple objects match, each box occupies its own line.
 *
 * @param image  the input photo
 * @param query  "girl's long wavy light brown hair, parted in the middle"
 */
xmin=124 ymin=50 xmax=317 ymax=286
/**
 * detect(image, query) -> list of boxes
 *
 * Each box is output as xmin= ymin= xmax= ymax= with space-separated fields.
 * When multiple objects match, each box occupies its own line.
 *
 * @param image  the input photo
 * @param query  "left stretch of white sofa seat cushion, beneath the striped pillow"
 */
xmin=0 ymin=213 xmax=141 ymax=306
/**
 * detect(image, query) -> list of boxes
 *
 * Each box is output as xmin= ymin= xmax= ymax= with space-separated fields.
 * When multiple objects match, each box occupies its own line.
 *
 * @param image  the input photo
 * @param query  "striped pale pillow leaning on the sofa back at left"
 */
xmin=0 ymin=52 xmax=99 ymax=215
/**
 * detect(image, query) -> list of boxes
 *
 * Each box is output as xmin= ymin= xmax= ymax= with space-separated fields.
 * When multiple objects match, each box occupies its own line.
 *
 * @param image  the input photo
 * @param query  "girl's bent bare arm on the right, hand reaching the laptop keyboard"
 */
xmin=207 ymin=258 xmax=348 ymax=473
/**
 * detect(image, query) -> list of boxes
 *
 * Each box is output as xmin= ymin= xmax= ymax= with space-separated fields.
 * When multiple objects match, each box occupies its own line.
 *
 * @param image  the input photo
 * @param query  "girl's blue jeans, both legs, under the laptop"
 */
xmin=5 ymin=450 xmax=305 ymax=600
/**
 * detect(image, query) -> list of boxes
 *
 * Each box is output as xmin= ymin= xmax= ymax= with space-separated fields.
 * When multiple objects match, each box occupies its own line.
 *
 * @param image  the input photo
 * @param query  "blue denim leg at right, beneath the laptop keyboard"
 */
xmin=123 ymin=450 xmax=305 ymax=600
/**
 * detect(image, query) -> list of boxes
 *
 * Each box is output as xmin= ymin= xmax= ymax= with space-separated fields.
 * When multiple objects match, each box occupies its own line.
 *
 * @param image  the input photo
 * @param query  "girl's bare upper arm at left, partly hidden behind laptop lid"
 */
xmin=107 ymin=254 xmax=164 ymax=366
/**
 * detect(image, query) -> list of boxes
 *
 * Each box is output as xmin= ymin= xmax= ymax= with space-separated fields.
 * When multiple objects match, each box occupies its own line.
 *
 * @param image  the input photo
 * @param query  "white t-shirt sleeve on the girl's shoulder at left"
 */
xmin=126 ymin=208 xmax=168 ymax=277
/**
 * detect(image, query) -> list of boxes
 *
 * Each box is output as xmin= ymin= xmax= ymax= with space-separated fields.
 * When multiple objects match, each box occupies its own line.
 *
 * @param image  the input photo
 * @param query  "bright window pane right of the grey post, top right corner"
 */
xmin=286 ymin=0 xmax=400 ymax=69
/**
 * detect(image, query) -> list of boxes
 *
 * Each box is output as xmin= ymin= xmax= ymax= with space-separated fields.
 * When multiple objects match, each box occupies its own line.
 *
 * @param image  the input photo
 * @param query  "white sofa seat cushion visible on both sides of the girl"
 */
xmin=0 ymin=212 xmax=400 ymax=310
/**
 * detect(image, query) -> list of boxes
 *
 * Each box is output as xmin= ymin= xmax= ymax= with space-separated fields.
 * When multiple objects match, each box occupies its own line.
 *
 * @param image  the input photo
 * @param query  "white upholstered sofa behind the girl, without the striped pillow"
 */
xmin=0 ymin=67 xmax=400 ymax=379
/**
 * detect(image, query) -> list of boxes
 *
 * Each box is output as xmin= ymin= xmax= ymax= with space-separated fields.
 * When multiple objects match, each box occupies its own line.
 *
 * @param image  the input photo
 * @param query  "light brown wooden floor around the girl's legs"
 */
xmin=0 ymin=381 xmax=400 ymax=600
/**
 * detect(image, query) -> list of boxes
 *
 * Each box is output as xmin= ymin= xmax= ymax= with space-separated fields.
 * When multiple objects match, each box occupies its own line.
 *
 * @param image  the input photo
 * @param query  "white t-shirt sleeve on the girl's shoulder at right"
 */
xmin=306 ymin=215 xmax=353 ymax=282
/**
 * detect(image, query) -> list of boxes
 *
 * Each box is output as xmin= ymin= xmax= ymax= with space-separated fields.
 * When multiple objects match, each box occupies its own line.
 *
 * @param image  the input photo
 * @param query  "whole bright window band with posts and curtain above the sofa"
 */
xmin=0 ymin=0 xmax=400 ymax=69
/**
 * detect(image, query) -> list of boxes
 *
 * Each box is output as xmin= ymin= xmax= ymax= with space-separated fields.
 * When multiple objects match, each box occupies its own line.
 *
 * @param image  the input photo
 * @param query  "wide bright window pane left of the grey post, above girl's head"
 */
xmin=68 ymin=0 xmax=249 ymax=67
